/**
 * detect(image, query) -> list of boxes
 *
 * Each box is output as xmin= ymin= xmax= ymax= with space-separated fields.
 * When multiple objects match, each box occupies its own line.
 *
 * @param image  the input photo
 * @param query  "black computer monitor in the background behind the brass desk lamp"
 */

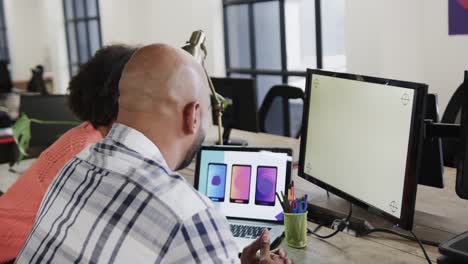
xmin=211 ymin=77 xmax=259 ymax=145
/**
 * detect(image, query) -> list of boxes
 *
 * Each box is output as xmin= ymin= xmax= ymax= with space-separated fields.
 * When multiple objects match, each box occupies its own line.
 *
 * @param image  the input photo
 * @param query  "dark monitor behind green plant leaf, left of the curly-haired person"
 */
xmin=20 ymin=95 xmax=79 ymax=157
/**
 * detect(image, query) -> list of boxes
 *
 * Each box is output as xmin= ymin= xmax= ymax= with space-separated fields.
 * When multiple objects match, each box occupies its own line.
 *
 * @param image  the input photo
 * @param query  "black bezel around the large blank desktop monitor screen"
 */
xmin=298 ymin=69 xmax=428 ymax=230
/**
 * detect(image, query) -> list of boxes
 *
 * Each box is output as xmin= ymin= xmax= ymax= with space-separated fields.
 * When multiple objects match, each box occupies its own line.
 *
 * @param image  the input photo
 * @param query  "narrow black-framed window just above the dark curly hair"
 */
xmin=63 ymin=0 xmax=102 ymax=76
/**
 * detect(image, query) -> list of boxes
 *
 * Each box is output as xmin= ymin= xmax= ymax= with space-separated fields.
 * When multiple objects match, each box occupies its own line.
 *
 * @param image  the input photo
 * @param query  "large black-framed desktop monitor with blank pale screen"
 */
xmin=299 ymin=69 xmax=427 ymax=229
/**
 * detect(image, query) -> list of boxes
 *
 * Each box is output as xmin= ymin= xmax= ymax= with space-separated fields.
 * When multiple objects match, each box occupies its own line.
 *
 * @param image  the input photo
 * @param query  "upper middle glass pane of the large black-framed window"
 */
xmin=254 ymin=1 xmax=281 ymax=70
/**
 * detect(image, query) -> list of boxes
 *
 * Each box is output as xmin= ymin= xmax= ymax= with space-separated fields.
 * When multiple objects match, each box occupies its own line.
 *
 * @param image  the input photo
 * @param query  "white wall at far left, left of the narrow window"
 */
xmin=4 ymin=0 xmax=69 ymax=93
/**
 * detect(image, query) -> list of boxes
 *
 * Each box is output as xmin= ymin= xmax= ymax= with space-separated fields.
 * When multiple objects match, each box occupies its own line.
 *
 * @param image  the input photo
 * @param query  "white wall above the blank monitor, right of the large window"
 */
xmin=346 ymin=0 xmax=468 ymax=111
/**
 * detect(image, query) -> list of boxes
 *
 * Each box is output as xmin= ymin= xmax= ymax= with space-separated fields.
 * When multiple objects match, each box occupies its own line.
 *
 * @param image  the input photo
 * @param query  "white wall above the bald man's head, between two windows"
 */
xmin=100 ymin=0 xmax=225 ymax=75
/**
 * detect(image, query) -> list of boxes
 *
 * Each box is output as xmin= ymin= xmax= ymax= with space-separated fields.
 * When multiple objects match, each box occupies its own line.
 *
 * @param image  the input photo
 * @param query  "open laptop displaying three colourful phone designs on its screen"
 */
xmin=195 ymin=146 xmax=292 ymax=251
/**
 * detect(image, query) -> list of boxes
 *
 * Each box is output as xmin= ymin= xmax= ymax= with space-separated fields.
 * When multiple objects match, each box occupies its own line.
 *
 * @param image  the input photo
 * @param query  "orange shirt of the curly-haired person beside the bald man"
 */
xmin=0 ymin=122 xmax=102 ymax=263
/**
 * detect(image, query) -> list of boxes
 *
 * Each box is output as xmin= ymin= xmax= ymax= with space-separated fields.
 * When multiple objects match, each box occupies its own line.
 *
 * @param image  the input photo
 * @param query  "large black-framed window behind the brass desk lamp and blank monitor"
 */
xmin=223 ymin=0 xmax=346 ymax=106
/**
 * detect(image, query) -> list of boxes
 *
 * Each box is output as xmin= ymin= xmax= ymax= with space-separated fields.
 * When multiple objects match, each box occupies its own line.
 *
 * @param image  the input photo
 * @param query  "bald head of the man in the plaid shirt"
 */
xmin=117 ymin=44 xmax=210 ymax=169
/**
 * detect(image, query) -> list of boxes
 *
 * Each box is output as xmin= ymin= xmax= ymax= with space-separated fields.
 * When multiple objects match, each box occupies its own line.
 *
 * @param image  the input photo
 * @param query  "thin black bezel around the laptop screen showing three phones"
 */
xmin=193 ymin=146 xmax=292 ymax=224
